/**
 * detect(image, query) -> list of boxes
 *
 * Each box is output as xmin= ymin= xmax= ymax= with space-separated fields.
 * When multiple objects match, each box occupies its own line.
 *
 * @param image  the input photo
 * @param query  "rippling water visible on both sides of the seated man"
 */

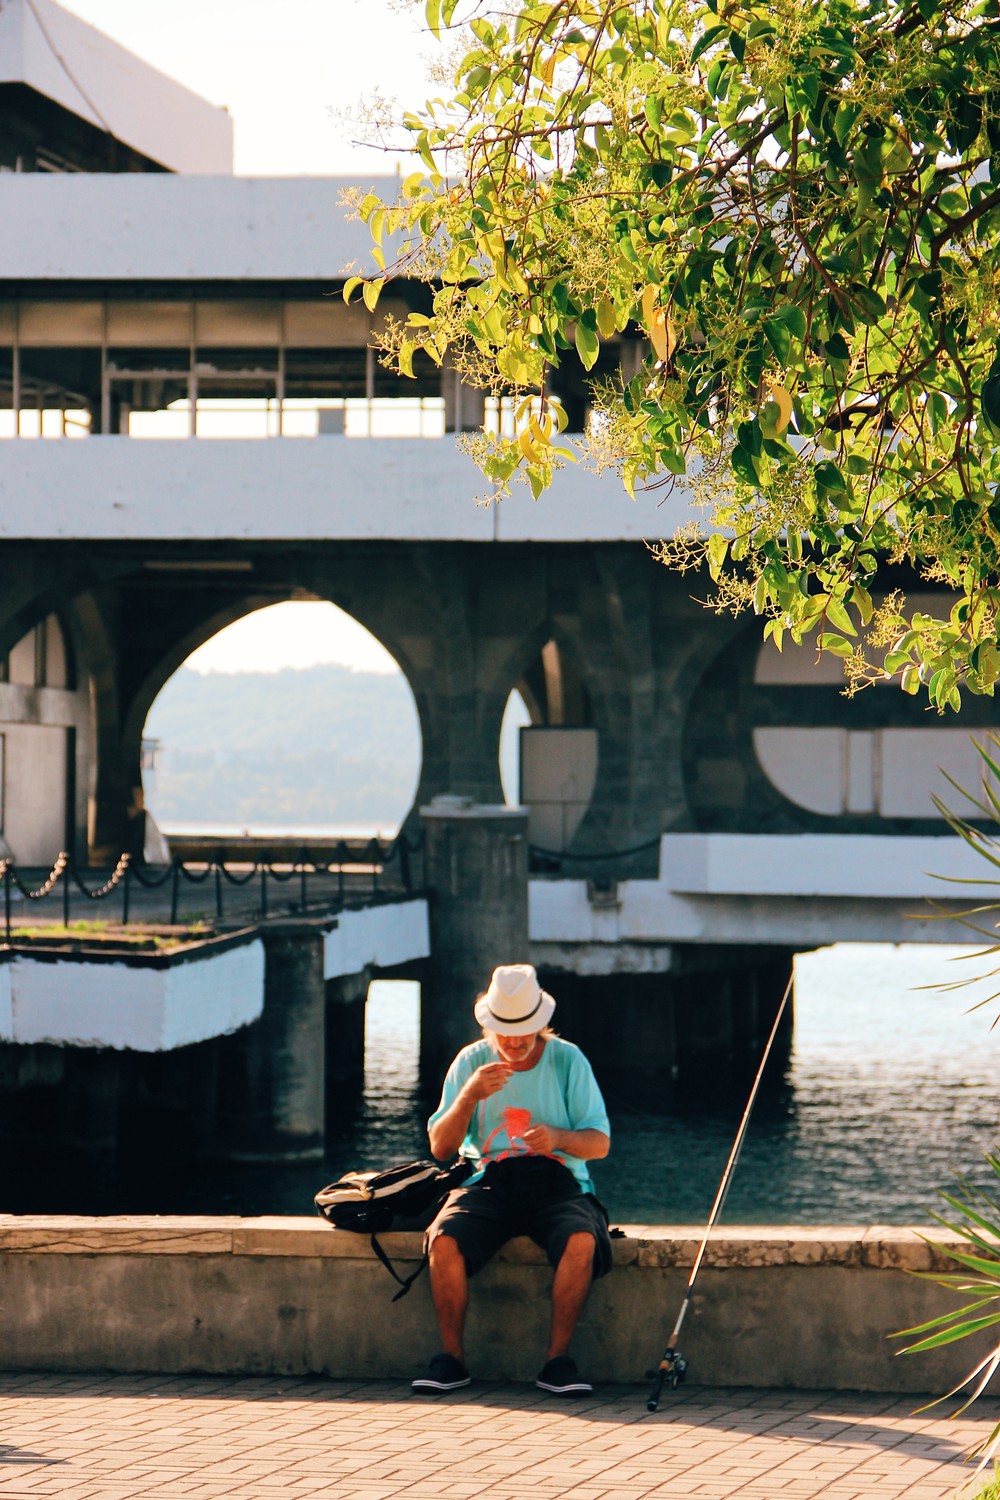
xmin=150 ymin=945 xmax=1000 ymax=1224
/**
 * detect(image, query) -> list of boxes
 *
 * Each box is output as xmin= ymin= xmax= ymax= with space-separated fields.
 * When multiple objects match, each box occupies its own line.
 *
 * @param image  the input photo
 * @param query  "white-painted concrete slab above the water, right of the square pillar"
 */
xmin=528 ymin=831 xmax=990 ymax=954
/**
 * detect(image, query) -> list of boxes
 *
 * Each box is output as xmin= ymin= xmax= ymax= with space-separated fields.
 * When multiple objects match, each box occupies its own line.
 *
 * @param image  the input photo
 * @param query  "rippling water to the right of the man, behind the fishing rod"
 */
xmin=595 ymin=944 xmax=1000 ymax=1224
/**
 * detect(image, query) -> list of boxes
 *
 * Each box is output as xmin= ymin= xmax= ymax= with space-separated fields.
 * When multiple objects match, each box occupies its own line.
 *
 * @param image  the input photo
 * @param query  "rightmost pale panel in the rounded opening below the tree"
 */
xmin=879 ymin=729 xmax=996 ymax=818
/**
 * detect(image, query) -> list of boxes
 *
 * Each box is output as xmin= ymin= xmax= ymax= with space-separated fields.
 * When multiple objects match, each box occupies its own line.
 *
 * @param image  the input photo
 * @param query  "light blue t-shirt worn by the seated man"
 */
xmin=427 ymin=1037 xmax=610 ymax=1193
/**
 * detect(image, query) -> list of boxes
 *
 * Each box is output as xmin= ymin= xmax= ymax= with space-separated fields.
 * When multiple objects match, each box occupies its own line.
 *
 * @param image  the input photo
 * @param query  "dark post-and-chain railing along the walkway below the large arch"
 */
xmin=0 ymin=836 xmax=417 ymax=944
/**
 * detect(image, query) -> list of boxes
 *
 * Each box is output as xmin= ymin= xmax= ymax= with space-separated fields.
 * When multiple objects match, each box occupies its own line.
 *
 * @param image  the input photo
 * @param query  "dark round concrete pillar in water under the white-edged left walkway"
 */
xmin=213 ymin=920 xmax=330 ymax=1161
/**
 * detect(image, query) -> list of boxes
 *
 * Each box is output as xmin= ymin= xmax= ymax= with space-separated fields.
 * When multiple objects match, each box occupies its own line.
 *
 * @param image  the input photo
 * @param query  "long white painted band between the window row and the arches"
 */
xmin=0 ymin=438 xmax=691 ymax=542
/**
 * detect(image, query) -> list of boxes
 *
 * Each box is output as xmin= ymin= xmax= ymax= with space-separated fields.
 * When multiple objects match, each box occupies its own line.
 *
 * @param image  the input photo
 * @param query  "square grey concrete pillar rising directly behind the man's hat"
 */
xmin=420 ymin=797 xmax=528 ymax=1085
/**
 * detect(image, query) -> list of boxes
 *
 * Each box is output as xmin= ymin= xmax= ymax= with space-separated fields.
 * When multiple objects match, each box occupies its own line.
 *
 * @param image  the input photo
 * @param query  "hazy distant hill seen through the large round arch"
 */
xmin=145 ymin=665 xmax=420 ymax=830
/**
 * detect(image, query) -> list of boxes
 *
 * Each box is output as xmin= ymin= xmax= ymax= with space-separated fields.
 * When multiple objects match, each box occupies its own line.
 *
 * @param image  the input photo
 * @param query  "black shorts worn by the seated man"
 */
xmin=424 ymin=1157 xmax=612 ymax=1280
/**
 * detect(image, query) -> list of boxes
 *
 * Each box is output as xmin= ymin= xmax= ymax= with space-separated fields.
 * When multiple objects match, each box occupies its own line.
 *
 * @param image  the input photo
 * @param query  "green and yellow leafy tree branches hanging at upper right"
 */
xmin=358 ymin=0 xmax=1000 ymax=710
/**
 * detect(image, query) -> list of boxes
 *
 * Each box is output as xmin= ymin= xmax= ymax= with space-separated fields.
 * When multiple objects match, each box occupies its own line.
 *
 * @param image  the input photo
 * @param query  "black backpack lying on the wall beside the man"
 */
xmin=313 ymin=1158 xmax=472 ymax=1302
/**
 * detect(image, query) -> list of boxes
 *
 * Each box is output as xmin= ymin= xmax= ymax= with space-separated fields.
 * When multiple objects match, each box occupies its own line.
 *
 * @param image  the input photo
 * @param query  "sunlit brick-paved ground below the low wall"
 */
xmin=0 ymin=1376 xmax=996 ymax=1500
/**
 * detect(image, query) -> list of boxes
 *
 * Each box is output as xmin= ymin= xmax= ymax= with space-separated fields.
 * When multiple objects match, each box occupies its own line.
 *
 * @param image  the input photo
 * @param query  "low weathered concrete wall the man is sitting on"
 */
xmin=0 ymin=1215 xmax=988 ymax=1400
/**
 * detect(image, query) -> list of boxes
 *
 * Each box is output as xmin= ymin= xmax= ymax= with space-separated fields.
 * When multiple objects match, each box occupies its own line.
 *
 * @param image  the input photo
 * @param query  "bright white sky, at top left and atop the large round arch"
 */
xmin=60 ymin=0 xmax=438 ymax=672
